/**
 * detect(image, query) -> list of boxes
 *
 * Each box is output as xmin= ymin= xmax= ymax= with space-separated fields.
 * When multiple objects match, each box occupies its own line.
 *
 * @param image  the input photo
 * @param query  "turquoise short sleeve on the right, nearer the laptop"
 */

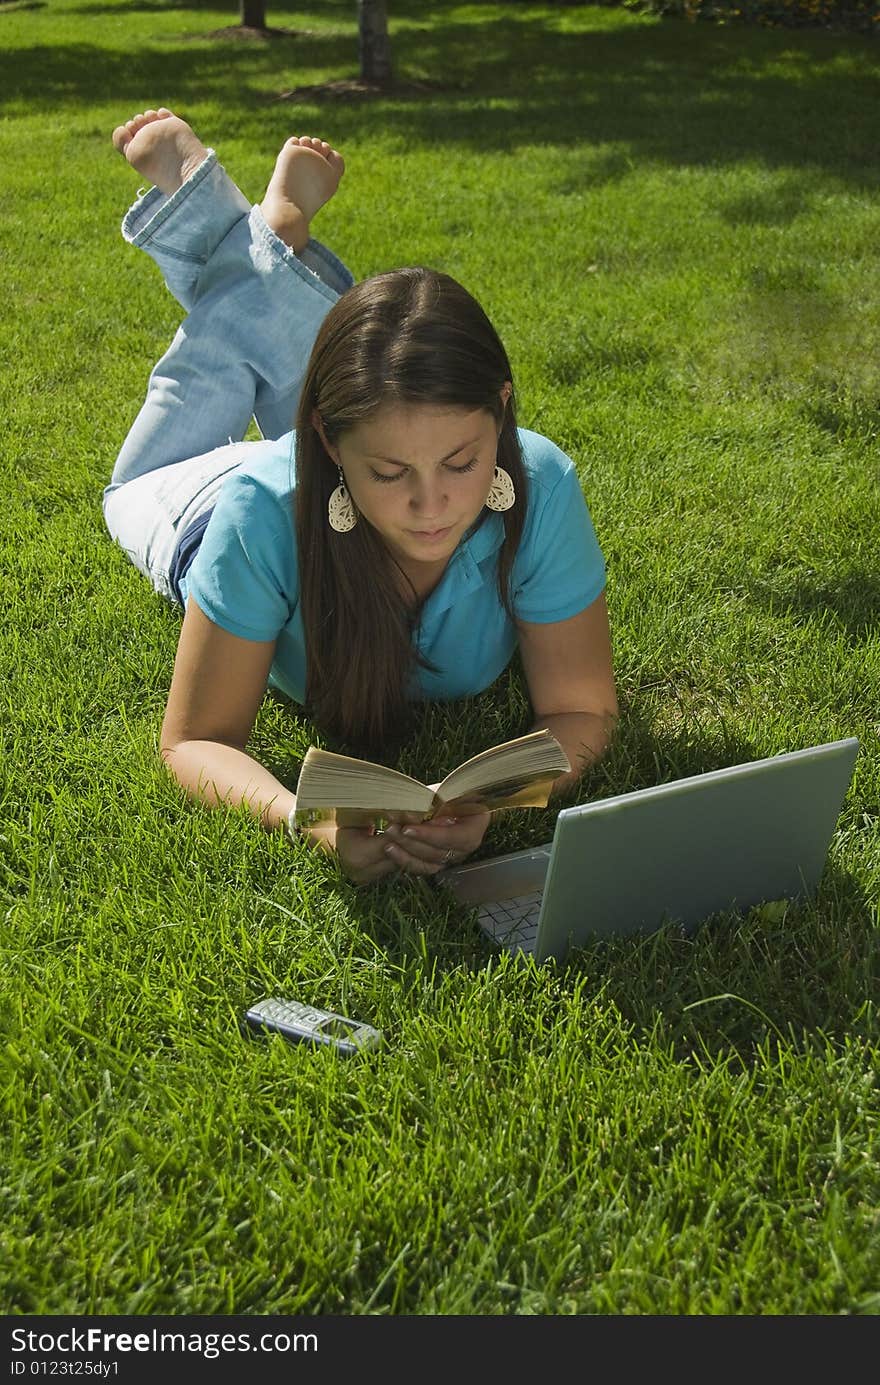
xmin=513 ymin=445 xmax=606 ymax=625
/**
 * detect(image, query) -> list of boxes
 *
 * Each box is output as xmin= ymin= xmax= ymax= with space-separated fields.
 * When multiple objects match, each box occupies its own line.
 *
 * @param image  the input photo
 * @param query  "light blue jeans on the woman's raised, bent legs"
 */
xmin=104 ymin=150 xmax=353 ymax=600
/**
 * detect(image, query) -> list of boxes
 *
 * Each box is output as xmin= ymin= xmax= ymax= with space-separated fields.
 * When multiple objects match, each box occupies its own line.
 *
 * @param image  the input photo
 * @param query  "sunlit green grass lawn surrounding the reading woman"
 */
xmin=0 ymin=0 xmax=880 ymax=1314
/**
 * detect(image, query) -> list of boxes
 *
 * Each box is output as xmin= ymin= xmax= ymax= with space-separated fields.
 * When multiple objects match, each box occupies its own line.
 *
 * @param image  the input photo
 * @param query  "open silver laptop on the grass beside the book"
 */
xmin=438 ymin=738 xmax=859 ymax=963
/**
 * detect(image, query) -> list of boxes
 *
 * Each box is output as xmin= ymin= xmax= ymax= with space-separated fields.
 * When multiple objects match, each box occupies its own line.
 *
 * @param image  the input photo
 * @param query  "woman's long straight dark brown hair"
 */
xmin=295 ymin=267 xmax=527 ymax=753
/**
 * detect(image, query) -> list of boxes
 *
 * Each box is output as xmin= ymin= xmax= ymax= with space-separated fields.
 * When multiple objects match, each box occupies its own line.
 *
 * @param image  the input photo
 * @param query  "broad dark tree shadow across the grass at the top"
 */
xmin=0 ymin=9 xmax=879 ymax=189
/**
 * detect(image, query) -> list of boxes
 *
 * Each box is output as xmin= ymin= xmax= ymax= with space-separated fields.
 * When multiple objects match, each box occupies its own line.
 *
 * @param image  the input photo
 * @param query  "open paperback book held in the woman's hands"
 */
xmin=297 ymin=730 xmax=571 ymax=827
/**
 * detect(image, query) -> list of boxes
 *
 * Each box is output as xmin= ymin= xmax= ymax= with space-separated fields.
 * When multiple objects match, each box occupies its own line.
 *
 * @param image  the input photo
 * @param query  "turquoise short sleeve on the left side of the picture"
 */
xmin=187 ymin=475 xmax=298 ymax=641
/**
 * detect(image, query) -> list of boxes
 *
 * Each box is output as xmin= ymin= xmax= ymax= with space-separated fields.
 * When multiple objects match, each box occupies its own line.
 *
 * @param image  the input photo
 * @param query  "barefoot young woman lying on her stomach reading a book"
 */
xmin=104 ymin=108 xmax=617 ymax=882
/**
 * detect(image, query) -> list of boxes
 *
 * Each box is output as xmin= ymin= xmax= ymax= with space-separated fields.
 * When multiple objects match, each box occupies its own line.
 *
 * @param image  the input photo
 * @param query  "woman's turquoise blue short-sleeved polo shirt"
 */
xmin=179 ymin=428 xmax=606 ymax=704
